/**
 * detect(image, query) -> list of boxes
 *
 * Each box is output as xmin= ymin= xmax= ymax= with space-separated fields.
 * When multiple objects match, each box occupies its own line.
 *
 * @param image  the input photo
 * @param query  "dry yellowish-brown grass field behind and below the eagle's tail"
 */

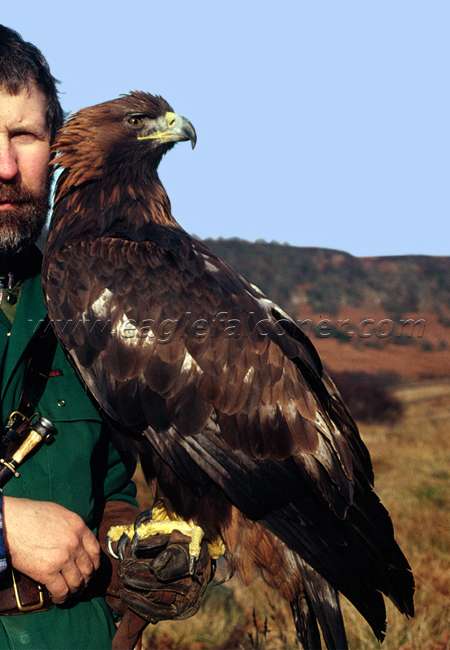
xmin=138 ymin=380 xmax=450 ymax=650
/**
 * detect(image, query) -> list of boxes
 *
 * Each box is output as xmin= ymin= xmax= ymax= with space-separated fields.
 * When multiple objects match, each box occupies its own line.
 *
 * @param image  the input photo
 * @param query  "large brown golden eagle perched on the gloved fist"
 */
xmin=43 ymin=92 xmax=414 ymax=650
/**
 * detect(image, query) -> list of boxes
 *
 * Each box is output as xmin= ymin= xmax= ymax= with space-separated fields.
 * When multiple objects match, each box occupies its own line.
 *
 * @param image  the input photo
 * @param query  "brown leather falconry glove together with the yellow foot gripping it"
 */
xmin=100 ymin=502 xmax=217 ymax=650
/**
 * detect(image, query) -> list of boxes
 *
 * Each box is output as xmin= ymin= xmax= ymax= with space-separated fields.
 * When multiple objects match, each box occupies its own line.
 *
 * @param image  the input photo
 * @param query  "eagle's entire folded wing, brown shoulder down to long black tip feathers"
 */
xmin=43 ymin=225 xmax=412 ymax=636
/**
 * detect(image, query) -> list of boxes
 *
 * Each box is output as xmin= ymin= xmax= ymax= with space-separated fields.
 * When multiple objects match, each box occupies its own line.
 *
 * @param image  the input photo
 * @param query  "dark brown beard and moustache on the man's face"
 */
xmin=0 ymin=178 xmax=50 ymax=255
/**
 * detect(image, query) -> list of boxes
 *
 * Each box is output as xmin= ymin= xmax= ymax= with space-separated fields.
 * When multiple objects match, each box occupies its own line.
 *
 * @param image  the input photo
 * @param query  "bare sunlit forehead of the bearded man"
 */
xmin=0 ymin=82 xmax=47 ymax=131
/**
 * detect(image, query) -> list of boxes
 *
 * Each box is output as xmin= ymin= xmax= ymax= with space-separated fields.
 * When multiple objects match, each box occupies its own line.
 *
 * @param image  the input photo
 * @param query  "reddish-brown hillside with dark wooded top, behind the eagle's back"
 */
xmin=205 ymin=239 xmax=450 ymax=380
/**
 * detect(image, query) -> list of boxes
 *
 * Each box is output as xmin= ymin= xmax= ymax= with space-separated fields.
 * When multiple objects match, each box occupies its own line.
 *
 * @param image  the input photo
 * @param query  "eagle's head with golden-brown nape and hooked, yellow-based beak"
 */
xmin=52 ymin=91 xmax=197 ymax=196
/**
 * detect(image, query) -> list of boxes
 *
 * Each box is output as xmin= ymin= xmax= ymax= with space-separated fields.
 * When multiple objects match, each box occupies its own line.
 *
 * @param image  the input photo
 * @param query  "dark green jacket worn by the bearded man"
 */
xmin=0 ymin=264 xmax=136 ymax=650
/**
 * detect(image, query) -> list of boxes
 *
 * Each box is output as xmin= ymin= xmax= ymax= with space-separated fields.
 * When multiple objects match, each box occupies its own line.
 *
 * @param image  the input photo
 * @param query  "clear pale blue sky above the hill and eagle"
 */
xmin=1 ymin=0 xmax=450 ymax=255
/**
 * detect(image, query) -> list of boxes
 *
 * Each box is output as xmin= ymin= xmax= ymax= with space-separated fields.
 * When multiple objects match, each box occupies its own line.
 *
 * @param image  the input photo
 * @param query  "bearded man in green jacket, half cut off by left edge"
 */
xmin=0 ymin=26 xmax=211 ymax=650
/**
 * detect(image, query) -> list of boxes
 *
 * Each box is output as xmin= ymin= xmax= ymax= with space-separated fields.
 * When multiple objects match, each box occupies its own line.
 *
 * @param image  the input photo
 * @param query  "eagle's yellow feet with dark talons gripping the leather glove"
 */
xmin=108 ymin=503 xmax=225 ymax=573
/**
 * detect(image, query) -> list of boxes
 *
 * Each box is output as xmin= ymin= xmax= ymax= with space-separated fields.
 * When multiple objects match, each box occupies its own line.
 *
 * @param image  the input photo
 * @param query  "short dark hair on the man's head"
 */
xmin=0 ymin=25 xmax=64 ymax=141
